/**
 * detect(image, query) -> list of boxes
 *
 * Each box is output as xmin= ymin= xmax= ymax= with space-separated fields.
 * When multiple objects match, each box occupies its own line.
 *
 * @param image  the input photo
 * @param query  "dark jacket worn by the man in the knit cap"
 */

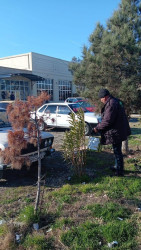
xmin=96 ymin=95 xmax=131 ymax=144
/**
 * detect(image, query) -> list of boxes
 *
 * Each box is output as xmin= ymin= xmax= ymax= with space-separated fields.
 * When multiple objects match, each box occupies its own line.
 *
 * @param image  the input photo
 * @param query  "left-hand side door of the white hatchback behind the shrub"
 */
xmin=43 ymin=105 xmax=57 ymax=127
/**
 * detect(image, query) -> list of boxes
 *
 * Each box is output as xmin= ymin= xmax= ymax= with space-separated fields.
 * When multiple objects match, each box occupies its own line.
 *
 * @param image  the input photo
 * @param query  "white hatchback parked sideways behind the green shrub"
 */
xmin=31 ymin=103 xmax=101 ymax=135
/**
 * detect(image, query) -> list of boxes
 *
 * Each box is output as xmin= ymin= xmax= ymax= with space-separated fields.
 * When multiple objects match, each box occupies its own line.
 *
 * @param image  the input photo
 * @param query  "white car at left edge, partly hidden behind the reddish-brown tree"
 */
xmin=0 ymin=110 xmax=54 ymax=175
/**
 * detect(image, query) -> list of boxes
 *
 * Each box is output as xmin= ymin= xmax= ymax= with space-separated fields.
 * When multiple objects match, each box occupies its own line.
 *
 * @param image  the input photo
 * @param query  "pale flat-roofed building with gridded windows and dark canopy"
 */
xmin=0 ymin=52 xmax=76 ymax=102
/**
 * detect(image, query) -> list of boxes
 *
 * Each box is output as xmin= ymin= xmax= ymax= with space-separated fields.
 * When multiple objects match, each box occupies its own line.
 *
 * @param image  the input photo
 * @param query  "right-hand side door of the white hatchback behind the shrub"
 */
xmin=57 ymin=105 xmax=72 ymax=128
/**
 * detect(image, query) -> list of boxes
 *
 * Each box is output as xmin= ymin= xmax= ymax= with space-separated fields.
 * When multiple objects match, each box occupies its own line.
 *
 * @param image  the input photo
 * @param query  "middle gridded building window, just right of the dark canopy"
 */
xmin=36 ymin=79 xmax=53 ymax=101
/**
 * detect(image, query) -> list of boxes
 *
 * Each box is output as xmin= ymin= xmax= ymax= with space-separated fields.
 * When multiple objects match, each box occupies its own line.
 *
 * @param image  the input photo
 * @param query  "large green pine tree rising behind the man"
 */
xmin=70 ymin=0 xmax=141 ymax=115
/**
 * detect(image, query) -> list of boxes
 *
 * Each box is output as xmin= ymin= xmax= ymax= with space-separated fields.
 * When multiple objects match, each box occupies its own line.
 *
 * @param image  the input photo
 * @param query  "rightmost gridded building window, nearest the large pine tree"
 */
xmin=59 ymin=80 xmax=72 ymax=101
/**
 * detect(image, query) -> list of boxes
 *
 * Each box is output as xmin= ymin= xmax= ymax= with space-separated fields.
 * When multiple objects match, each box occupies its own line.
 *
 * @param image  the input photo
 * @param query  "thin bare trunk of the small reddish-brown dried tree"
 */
xmin=34 ymin=129 xmax=41 ymax=213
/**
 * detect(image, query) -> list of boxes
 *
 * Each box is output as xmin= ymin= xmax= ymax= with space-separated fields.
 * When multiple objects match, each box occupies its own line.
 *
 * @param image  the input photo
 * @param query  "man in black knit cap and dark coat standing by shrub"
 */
xmin=94 ymin=89 xmax=131 ymax=176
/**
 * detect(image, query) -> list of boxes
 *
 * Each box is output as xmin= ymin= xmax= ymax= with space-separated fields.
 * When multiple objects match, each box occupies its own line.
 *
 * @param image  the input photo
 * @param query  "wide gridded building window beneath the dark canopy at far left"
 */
xmin=0 ymin=79 xmax=29 ymax=100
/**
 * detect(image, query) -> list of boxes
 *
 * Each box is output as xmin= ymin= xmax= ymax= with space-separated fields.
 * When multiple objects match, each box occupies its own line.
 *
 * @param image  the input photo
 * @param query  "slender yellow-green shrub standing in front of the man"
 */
xmin=62 ymin=109 xmax=86 ymax=177
